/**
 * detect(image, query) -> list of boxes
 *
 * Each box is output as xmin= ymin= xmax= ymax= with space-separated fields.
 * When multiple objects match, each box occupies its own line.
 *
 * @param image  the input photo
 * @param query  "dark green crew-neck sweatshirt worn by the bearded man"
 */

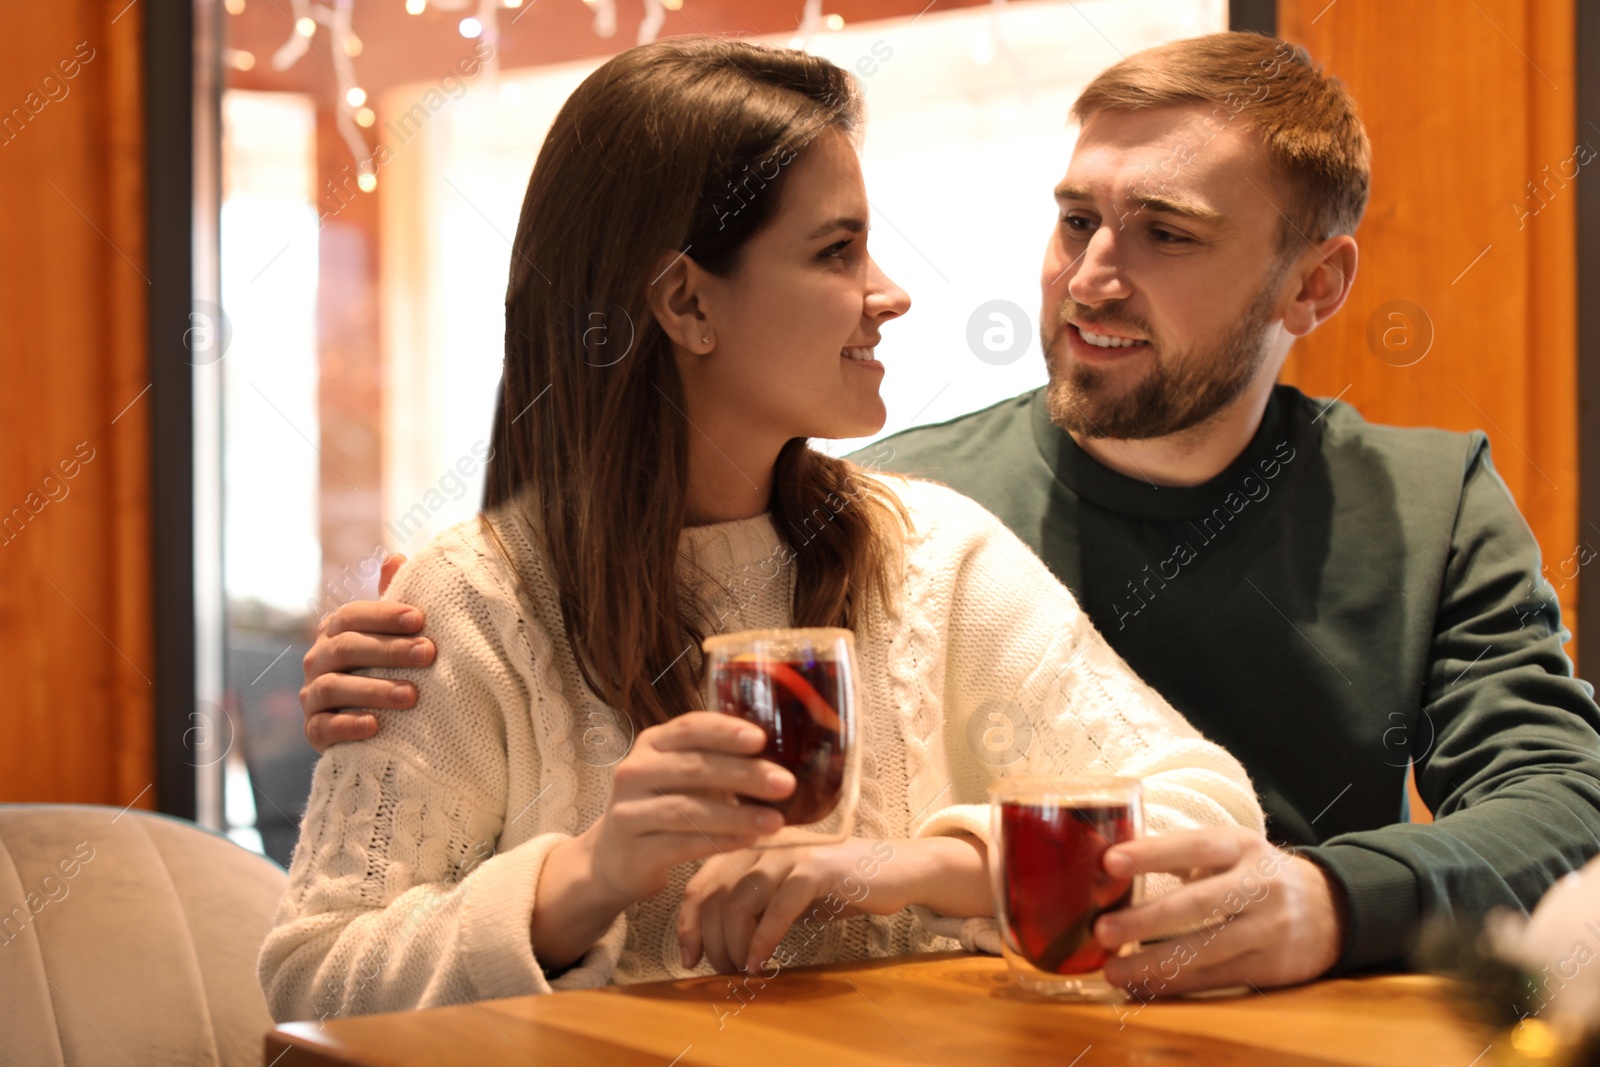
xmin=851 ymin=386 xmax=1600 ymax=971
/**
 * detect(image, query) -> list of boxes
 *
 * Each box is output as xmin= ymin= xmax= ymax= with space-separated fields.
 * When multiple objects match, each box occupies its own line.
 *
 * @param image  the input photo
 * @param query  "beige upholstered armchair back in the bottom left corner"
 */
xmin=0 ymin=805 xmax=285 ymax=1067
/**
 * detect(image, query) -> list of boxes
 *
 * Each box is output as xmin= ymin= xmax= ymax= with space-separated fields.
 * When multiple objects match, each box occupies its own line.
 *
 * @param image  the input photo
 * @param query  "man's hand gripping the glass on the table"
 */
xmin=1094 ymin=827 xmax=1346 ymax=1001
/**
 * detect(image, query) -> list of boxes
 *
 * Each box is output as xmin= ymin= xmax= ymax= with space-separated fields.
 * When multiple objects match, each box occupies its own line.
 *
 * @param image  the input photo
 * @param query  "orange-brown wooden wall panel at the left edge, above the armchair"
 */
xmin=0 ymin=0 xmax=154 ymax=806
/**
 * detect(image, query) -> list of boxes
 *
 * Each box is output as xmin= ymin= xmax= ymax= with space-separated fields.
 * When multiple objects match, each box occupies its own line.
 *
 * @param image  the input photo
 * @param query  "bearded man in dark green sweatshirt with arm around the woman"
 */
xmin=302 ymin=34 xmax=1600 ymax=1000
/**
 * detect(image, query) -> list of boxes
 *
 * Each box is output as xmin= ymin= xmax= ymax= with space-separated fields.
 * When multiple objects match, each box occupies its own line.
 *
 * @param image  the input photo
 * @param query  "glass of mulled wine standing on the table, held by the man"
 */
xmin=989 ymin=776 xmax=1144 ymax=1000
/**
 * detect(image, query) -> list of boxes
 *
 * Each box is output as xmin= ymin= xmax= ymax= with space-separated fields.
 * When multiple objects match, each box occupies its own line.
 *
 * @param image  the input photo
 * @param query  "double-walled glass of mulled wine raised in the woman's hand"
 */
xmin=704 ymin=627 xmax=861 ymax=848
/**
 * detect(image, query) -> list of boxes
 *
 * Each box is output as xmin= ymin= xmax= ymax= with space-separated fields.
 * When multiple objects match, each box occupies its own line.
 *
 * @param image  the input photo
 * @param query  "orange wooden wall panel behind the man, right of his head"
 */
xmin=1278 ymin=0 xmax=1580 ymax=657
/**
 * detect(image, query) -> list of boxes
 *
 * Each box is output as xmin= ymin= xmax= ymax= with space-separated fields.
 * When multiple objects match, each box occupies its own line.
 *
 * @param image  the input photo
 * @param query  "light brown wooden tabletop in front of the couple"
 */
xmin=264 ymin=953 xmax=1490 ymax=1067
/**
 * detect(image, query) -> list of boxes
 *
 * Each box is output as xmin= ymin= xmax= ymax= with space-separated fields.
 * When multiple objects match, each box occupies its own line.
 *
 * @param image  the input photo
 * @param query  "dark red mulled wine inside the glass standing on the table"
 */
xmin=1000 ymin=801 xmax=1134 ymax=974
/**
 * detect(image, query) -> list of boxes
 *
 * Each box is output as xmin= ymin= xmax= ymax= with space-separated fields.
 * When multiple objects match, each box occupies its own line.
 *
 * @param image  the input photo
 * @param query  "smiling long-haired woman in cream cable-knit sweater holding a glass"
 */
xmin=261 ymin=38 xmax=1261 ymax=1019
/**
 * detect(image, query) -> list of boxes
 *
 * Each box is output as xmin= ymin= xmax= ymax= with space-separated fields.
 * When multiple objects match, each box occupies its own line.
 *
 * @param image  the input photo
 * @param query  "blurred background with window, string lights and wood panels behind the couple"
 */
xmin=0 ymin=0 xmax=1600 ymax=862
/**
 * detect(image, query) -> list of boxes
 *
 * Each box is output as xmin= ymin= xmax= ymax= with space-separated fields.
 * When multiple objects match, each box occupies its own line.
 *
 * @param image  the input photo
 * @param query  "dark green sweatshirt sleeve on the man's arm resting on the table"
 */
xmin=1301 ymin=434 xmax=1600 ymax=973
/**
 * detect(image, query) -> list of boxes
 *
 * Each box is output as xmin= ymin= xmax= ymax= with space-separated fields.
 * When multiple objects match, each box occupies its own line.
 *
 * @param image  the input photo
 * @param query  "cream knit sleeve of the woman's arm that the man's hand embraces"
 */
xmin=258 ymin=528 xmax=626 ymax=1021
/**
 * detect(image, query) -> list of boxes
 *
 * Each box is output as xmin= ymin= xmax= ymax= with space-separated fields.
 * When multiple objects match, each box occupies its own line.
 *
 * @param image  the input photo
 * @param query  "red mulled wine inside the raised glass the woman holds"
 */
xmin=712 ymin=657 xmax=850 ymax=825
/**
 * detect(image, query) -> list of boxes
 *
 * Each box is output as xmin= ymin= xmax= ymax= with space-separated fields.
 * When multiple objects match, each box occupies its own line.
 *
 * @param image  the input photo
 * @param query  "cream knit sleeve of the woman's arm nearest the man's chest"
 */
xmin=906 ymin=483 xmax=1264 ymax=896
